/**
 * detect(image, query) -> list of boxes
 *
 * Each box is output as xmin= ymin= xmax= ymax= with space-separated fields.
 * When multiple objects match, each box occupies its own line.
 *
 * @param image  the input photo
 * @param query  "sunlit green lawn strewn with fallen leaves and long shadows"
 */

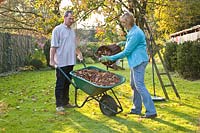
xmin=0 ymin=64 xmax=200 ymax=133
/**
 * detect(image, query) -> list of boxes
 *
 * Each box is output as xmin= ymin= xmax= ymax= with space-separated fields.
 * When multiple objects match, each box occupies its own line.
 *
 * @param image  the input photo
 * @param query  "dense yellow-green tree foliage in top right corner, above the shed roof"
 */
xmin=152 ymin=0 xmax=200 ymax=41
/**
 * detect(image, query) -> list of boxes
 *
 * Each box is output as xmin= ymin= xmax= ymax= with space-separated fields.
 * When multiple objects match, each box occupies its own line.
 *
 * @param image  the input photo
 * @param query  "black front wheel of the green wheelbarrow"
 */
xmin=99 ymin=95 xmax=117 ymax=116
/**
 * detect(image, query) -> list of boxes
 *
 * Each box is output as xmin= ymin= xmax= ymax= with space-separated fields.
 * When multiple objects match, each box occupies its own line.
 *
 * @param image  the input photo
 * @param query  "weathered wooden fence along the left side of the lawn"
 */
xmin=0 ymin=33 xmax=34 ymax=73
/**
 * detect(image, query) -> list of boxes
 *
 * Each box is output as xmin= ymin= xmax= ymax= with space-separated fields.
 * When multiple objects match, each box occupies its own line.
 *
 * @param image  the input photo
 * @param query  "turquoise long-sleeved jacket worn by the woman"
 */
xmin=109 ymin=25 xmax=149 ymax=68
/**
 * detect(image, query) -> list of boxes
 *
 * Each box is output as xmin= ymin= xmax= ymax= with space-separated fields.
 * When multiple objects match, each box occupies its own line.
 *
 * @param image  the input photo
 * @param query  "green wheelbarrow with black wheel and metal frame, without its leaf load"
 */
xmin=57 ymin=62 xmax=126 ymax=116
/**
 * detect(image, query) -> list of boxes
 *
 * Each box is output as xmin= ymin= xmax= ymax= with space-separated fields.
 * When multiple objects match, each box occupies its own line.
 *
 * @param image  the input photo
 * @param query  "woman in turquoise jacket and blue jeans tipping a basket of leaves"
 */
xmin=100 ymin=13 xmax=157 ymax=118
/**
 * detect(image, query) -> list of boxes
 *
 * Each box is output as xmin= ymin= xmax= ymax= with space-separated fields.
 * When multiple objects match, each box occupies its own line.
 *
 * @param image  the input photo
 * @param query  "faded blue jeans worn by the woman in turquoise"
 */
xmin=131 ymin=62 xmax=156 ymax=115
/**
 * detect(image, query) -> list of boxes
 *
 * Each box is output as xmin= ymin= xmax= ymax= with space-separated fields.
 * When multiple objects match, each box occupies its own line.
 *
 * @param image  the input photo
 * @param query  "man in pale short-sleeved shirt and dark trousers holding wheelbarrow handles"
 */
xmin=49 ymin=11 xmax=83 ymax=112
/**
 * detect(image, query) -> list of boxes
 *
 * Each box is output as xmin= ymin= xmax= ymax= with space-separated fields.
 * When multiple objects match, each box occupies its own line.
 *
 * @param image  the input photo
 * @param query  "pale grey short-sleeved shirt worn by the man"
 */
xmin=51 ymin=24 xmax=76 ymax=67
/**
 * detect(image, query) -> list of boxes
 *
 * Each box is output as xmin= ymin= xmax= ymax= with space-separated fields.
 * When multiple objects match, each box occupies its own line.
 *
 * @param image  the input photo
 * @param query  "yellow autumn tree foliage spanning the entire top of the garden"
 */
xmin=0 ymin=0 xmax=200 ymax=44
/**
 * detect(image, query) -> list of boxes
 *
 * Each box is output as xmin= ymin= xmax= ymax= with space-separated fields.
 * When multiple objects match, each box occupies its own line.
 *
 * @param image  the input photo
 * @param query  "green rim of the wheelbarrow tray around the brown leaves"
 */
xmin=70 ymin=66 xmax=126 ymax=89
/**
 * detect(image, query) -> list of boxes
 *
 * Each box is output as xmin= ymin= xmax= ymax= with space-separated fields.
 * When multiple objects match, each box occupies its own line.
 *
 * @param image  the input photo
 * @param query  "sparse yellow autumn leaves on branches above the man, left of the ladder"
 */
xmin=0 ymin=0 xmax=146 ymax=39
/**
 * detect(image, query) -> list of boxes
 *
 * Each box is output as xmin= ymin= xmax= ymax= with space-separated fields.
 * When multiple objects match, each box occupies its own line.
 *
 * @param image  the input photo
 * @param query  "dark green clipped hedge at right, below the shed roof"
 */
xmin=164 ymin=41 xmax=200 ymax=80
